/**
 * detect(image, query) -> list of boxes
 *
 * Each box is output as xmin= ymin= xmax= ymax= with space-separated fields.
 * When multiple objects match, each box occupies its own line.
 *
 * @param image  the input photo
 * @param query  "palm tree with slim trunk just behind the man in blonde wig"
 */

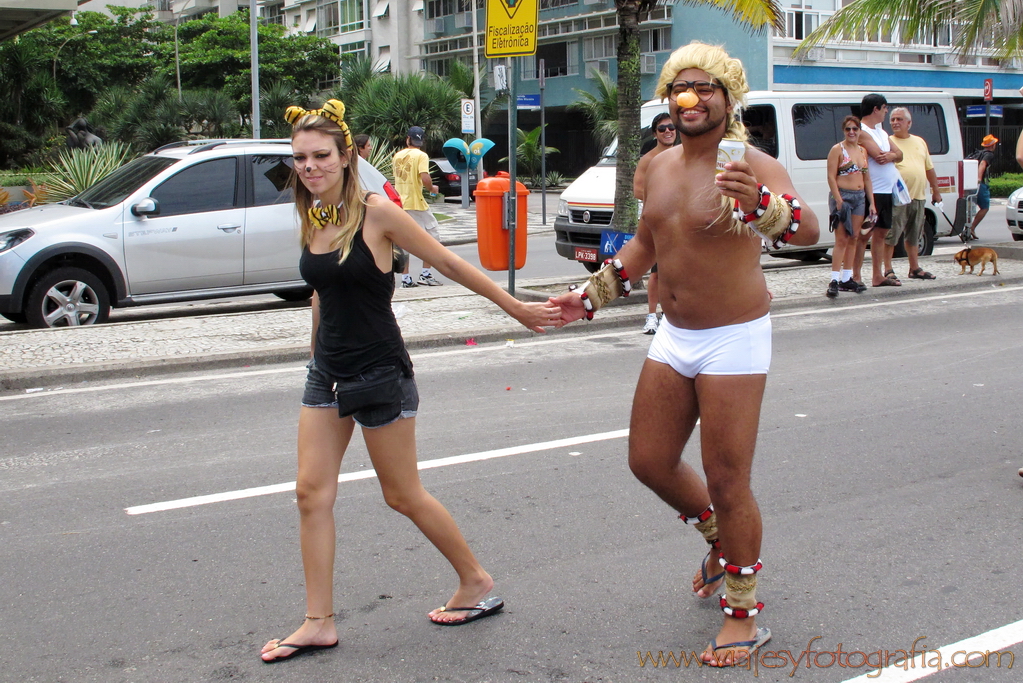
xmin=614 ymin=0 xmax=781 ymax=232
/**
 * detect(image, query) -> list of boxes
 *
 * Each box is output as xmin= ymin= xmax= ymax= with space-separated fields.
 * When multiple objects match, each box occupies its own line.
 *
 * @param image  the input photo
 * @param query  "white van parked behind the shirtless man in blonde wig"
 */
xmin=554 ymin=91 xmax=977 ymax=270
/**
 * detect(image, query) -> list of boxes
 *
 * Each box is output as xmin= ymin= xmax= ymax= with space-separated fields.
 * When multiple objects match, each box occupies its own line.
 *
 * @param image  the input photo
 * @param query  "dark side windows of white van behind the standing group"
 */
xmin=792 ymin=101 xmax=948 ymax=161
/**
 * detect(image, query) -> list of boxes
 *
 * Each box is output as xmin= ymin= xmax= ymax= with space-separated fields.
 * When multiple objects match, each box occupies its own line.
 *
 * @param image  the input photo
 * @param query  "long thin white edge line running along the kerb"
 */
xmin=7 ymin=285 xmax=1023 ymax=402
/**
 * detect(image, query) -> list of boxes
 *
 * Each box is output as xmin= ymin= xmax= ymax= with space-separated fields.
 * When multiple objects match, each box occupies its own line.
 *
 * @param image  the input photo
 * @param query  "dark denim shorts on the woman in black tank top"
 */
xmin=302 ymin=360 xmax=419 ymax=429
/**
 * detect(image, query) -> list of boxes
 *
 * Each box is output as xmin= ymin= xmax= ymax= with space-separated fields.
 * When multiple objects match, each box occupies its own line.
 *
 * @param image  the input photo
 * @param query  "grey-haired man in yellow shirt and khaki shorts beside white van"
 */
xmin=884 ymin=106 xmax=941 ymax=280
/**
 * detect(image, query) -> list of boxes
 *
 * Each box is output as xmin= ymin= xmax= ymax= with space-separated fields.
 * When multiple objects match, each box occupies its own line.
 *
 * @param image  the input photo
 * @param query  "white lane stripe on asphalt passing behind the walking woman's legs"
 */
xmin=125 ymin=429 xmax=629 ymax=514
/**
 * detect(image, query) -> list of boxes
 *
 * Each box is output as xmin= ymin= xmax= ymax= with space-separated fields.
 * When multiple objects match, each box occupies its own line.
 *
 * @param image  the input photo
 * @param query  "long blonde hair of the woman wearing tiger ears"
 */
xmin=291 ymin=112 xmax=366 ymax=263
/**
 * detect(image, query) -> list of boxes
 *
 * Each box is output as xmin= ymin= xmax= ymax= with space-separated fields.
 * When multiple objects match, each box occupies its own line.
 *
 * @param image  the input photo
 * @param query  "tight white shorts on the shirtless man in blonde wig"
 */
xmin=647 ymin=313 xmax=770 ymax=379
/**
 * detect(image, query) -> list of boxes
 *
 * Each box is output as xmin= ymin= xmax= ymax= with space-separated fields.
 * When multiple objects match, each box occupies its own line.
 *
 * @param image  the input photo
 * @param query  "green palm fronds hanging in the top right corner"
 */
xmin=796 ymin=0 xmax=1023 ymax=57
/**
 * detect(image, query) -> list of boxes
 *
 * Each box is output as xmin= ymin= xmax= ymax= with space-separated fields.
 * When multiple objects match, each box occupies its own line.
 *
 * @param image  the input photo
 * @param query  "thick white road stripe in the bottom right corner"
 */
xmin=844 ymin=621 xmax=1023 ymax=683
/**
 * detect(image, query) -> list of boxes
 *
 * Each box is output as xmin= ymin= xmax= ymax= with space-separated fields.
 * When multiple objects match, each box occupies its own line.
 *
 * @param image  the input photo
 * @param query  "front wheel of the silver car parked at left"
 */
xmin=25 ymin=268 xmax=110 ymax=327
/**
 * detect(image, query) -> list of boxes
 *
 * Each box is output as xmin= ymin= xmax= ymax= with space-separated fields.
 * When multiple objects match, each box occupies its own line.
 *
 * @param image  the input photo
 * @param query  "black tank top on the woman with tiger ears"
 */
xmin=299 ymin=206 xmax=411 ymax=379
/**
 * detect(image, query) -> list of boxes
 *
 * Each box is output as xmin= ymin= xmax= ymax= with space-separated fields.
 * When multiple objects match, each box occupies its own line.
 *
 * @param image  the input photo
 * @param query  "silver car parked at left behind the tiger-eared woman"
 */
xmin=0 ymin=140 xmax=401 ymax=327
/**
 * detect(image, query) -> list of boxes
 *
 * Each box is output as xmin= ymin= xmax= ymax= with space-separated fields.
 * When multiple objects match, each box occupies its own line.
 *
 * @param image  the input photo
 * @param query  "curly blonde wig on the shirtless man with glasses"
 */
xmin=654 ymin=41 xmax=750 ymax=142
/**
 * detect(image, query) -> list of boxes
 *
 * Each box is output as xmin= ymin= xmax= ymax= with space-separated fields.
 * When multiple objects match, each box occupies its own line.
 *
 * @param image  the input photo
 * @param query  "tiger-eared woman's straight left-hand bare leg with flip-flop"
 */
xmin=261 ymin=406 xmax=355 ymax=662
